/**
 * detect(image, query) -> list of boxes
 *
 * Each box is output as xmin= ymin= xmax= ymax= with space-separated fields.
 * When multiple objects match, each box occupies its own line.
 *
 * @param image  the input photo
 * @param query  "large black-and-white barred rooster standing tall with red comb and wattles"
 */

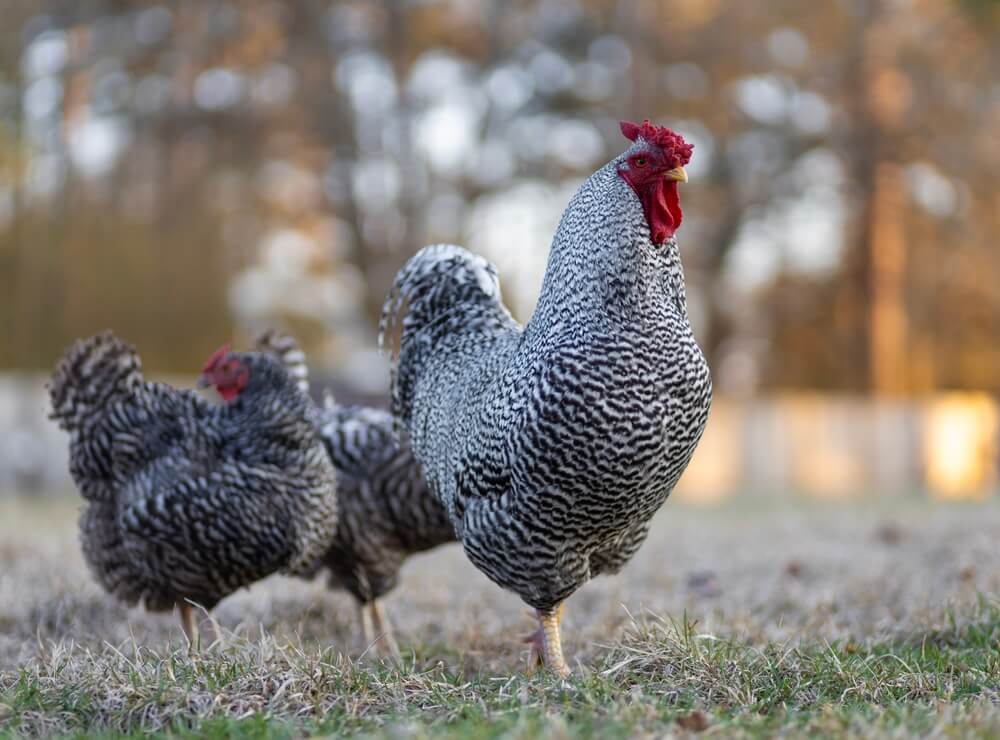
xmin=381 ymin=121 xmax=712 ymax=676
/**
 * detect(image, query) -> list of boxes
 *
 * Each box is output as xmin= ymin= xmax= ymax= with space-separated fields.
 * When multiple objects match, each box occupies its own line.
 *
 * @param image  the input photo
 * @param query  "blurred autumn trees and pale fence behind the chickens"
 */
xmin=0 ymin=0 xmax=1000 ymax=500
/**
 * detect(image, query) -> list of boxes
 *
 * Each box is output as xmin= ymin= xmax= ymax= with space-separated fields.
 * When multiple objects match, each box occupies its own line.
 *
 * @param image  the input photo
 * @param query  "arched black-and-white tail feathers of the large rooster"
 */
xmin=379 ymin=244 xmax=514 ymax=422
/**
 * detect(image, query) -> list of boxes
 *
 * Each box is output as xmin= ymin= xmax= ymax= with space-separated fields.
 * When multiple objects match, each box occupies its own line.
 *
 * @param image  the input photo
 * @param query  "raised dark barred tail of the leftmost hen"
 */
xmin=48 ymin=331 xmax=143 ymax=431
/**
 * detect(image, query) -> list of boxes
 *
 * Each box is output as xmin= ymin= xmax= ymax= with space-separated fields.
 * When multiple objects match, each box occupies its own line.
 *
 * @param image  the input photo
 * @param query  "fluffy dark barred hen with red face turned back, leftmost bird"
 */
xmin=49 ymin=332 xmax=337 ymax=647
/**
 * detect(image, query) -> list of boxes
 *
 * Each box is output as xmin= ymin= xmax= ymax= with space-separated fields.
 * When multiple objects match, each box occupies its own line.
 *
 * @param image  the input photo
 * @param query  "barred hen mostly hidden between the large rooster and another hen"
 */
xmin=256 ymin=331 xmax=455 ymax=658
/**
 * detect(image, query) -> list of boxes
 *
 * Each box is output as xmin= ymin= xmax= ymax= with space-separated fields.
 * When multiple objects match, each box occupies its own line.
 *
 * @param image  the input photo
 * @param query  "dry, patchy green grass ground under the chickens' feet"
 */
xmin=0 ymin=495 xmax=1000 ymax=738
